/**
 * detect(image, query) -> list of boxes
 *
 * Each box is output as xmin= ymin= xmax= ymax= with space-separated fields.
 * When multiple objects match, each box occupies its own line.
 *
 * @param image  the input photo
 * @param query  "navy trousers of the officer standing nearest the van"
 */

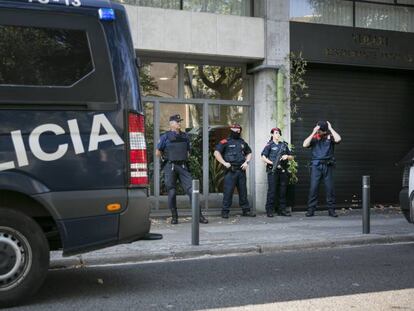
xmin=164 ymin=163 xmax=193 ymax=211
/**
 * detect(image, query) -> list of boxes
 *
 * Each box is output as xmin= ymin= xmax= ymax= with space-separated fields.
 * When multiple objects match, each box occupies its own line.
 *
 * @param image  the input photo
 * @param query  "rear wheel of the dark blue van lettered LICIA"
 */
xmin=0 ymin=208 xmax=50 ymax=307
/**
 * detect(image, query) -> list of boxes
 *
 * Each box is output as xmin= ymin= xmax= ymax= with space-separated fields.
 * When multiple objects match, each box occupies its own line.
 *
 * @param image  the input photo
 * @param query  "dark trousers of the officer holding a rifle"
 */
xmin=266 ymin=170 xmax=289 ymax=213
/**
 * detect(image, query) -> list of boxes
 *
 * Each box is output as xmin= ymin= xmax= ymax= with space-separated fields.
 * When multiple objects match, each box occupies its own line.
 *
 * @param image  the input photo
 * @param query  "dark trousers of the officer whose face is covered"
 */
xmin=223 ymin=169 xmax=250 ymax=213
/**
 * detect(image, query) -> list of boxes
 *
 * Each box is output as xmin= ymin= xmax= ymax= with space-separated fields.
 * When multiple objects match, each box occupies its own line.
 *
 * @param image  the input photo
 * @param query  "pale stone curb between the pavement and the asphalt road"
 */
xmin=50 ymin=233 xmax=414 ymax=269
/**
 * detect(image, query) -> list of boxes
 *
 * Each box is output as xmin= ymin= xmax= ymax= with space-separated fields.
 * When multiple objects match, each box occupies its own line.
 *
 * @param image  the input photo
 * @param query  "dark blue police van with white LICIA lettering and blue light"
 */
xmin=0 ymin=0 xmax=155 ymax=306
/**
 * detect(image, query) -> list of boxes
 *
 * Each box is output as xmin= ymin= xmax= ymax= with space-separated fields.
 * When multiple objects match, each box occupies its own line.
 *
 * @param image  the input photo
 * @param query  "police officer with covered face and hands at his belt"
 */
xmin=214 ymin=124 xmax=256 ymax=218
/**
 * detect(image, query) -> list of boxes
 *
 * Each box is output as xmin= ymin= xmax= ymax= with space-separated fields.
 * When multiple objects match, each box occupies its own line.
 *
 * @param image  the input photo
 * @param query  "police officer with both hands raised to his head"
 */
xmin=303 ymin=121 xmax=341 ymax=217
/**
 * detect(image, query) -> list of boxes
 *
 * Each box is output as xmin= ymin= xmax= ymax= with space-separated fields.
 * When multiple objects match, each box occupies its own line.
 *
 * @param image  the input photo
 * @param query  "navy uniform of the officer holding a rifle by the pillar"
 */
xmin=261 ymin=140 xmax=291 ymax=216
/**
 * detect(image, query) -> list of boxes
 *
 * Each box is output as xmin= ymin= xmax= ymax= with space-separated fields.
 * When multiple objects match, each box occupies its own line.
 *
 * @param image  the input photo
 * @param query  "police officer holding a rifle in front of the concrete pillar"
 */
xmin=262 ymin=127 xmax=293 ymax=217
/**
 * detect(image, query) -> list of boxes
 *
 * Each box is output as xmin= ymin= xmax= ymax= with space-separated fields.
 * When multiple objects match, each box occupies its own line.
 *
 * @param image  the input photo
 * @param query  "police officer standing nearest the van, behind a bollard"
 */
xmin=156 ymin=114 xmax=208 ymax=225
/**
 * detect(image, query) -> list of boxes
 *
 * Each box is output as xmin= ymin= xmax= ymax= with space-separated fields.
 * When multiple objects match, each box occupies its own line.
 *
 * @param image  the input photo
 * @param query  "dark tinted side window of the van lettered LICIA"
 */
xmin=0 ymin=25 xmax=93 ymax=86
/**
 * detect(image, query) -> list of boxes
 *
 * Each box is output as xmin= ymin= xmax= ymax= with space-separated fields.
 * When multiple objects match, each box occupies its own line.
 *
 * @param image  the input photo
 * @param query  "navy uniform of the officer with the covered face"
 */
xmin=216 ymin=137 xmax=252 ymax=215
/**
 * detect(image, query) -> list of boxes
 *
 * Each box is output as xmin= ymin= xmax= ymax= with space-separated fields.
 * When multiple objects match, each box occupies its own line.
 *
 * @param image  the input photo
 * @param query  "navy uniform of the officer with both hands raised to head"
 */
xmin=308 ymin=133 xmax=336 ymax=214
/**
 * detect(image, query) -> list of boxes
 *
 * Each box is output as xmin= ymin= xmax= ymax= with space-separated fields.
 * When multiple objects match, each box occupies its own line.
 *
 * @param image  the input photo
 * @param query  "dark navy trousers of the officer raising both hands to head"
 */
xmin=308 ymin=163 xmax=335 ymax=211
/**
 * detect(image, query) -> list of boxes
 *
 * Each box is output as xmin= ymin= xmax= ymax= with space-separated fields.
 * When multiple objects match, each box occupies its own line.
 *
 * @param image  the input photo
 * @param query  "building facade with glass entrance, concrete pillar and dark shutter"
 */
xmin=115 ymin=0 xmax=414 ymax=212
